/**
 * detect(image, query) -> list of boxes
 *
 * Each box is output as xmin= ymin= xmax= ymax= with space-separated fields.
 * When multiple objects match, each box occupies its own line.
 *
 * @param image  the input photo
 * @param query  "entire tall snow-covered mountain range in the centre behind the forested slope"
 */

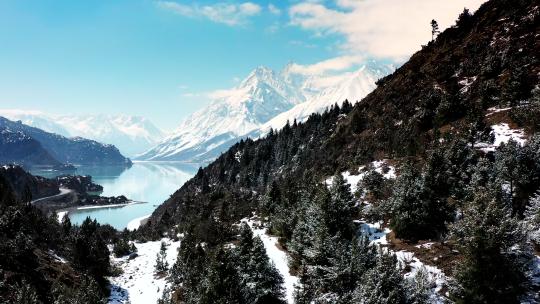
xmin=135 ymin=62 xmax=393 ymax=163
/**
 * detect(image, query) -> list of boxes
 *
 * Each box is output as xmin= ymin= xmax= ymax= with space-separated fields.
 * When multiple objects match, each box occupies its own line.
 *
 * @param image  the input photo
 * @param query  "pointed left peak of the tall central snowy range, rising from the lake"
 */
xmin=137 ymin=67 xmax=305 ymax=162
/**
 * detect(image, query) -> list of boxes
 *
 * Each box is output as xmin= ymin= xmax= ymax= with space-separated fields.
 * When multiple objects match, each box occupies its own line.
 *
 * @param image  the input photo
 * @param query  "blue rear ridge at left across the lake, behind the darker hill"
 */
xmin=0 ymin=117 xmax=131 ymax=166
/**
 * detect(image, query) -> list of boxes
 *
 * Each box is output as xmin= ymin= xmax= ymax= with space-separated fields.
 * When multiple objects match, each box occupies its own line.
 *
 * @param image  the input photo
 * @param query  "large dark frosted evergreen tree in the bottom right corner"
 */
xmin=452 ymin=189 xmax=527 ymax=303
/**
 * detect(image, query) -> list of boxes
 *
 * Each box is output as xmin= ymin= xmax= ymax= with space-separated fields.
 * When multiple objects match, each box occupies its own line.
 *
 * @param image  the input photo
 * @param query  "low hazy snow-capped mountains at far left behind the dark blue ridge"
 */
xmin=0 ymin=110 xmax=164 ymax=156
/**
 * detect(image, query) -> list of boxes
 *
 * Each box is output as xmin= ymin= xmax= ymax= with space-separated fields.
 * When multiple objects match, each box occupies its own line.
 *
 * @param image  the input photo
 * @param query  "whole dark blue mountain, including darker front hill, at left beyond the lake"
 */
xmin=0 ymin=117 xmax=131 ymax=166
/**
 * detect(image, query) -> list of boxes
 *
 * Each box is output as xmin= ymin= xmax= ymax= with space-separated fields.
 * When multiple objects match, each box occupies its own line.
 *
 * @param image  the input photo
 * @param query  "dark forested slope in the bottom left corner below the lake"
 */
xmin=0 ymin=172 xmax=118 ymax=304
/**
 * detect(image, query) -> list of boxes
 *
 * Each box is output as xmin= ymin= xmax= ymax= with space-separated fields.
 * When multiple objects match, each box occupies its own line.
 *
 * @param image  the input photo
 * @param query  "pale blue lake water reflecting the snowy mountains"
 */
xmin=32 ymin=162 xmax=198 ymax=229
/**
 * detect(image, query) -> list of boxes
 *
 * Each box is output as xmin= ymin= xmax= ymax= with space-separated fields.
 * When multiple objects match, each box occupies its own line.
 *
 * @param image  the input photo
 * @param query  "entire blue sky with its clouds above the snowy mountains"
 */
xmin=0 ymin=0 xmax=482 ymax=129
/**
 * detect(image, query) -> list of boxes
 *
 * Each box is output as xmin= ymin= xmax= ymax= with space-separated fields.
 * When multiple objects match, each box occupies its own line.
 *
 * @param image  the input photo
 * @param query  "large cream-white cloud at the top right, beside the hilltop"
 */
xmin=289 ymin=0 xmax=485 ymax=61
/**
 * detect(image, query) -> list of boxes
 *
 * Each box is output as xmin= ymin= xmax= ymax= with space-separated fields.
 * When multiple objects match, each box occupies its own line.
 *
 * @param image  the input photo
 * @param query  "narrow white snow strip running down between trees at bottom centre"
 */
xmin=242 ymin=219 xmax=298 ymax=304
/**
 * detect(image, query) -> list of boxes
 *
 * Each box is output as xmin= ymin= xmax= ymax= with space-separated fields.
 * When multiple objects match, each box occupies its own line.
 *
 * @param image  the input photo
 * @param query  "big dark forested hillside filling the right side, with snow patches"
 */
xmin=137 ymin=0 xmax=540 ymax=303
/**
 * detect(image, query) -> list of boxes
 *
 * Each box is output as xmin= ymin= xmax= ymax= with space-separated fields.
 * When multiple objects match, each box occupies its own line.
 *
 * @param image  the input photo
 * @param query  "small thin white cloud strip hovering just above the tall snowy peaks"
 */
xmin=291 ymin=56 xmax=364 ymax=75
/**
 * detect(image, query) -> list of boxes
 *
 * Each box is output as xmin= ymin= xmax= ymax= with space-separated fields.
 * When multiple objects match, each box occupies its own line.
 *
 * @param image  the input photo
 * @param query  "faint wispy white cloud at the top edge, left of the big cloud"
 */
xmin=157 ymin=1 xmax=262 ymax=26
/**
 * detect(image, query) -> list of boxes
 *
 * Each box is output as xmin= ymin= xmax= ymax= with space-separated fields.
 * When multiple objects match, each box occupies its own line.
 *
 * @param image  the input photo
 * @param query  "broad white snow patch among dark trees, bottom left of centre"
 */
xmin=109 ymin=238 xmax=180 ymax=304
